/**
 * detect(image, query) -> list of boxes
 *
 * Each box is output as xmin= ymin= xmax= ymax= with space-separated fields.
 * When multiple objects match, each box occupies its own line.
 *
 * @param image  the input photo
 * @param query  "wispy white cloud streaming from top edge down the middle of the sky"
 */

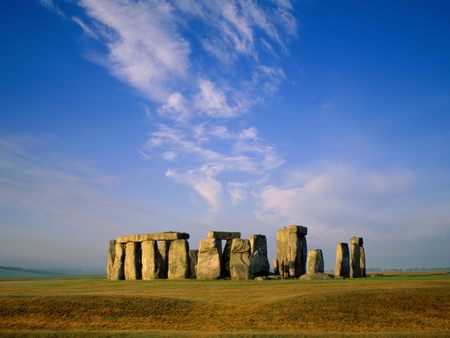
xmin=43 ymin=0 xmax=297 ymax=210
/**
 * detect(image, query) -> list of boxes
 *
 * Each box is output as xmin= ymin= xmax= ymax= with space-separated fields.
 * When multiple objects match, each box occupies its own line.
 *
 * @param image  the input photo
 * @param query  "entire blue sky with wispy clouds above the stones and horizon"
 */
xmin=0 ymin=0 xmax=450 ymax=270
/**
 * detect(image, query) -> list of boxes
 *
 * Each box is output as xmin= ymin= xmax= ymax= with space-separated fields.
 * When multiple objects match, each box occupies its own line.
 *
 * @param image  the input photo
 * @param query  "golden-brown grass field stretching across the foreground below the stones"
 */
xmin=0 ymin=273 xmax=450 ymax=337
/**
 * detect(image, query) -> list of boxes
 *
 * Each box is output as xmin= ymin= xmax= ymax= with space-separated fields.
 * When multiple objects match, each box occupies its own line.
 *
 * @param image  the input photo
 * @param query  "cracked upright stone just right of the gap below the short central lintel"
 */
xmin=230 ymin=238 xmax=252 ymax=280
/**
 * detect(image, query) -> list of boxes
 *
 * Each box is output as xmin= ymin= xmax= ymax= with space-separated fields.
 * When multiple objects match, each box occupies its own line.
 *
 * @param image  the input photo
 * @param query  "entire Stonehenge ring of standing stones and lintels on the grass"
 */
xmin=106 ymin=225 xmax=366 ymax=280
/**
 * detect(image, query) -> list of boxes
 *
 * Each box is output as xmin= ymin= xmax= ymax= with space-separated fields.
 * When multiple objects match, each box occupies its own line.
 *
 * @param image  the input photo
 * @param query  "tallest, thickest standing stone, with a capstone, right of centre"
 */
xmin=276 ymin=225 xmax=308 ymax=277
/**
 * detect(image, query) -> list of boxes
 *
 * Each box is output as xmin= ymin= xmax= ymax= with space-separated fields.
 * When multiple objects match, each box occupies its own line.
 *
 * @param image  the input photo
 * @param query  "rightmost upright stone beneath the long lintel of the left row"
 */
xmin=167 ymin=239 xmax=190 ymax=279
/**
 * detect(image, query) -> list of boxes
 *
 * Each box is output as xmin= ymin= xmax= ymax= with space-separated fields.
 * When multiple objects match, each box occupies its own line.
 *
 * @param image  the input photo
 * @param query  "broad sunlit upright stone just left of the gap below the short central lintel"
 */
xmin=197 ymin=238 xmax=222 ymax=279
